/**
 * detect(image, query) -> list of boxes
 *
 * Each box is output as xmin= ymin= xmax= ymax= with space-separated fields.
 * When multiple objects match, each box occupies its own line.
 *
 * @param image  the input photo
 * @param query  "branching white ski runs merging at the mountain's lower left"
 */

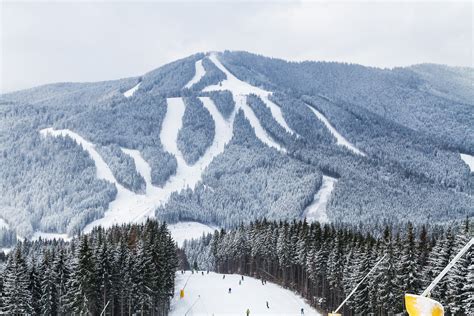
xmin=40 ymin=97 xmax=228 ymax=240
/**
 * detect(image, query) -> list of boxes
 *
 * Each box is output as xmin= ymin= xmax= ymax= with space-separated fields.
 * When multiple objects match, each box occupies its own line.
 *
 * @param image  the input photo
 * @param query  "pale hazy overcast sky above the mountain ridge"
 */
xmin=0 ymin=0 xmax=473 ymax=92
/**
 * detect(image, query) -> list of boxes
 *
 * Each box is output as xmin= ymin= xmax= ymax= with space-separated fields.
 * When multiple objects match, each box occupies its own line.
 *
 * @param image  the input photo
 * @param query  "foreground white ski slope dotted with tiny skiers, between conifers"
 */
xmin=170 ymin=271 xmax=321 ymax=316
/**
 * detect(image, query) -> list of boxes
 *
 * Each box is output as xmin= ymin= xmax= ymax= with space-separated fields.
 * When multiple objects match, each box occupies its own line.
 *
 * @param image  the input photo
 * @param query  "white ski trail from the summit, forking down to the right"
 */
xmin=203 ymin=54 xmax=288 ymax=153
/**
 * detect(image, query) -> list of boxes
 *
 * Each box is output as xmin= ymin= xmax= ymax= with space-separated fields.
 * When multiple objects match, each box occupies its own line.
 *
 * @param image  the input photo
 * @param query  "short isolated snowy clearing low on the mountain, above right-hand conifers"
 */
xmin=303 ymin=176 xmax=337 ymax=223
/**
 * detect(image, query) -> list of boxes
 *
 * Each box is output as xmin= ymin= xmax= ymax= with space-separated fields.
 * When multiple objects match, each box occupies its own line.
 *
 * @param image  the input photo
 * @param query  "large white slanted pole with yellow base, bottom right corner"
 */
xmin=405 ymin=238 xmax=474 ymax=316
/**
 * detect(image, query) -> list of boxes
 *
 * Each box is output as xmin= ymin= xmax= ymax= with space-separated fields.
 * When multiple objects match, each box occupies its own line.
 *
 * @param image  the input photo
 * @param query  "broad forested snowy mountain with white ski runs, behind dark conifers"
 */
xmin=0 ymin=51 xmax=474 ymax=241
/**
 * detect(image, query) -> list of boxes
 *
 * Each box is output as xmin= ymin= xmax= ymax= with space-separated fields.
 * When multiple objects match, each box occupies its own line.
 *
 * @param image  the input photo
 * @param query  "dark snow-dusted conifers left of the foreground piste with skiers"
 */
xmin=0 ymin=221 xmax=178 ymax=315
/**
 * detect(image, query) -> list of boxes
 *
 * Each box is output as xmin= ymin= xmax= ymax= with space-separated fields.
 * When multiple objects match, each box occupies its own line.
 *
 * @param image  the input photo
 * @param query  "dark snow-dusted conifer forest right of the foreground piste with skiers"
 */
xmin=183 ymin=220 xmax=474 ymax=315
